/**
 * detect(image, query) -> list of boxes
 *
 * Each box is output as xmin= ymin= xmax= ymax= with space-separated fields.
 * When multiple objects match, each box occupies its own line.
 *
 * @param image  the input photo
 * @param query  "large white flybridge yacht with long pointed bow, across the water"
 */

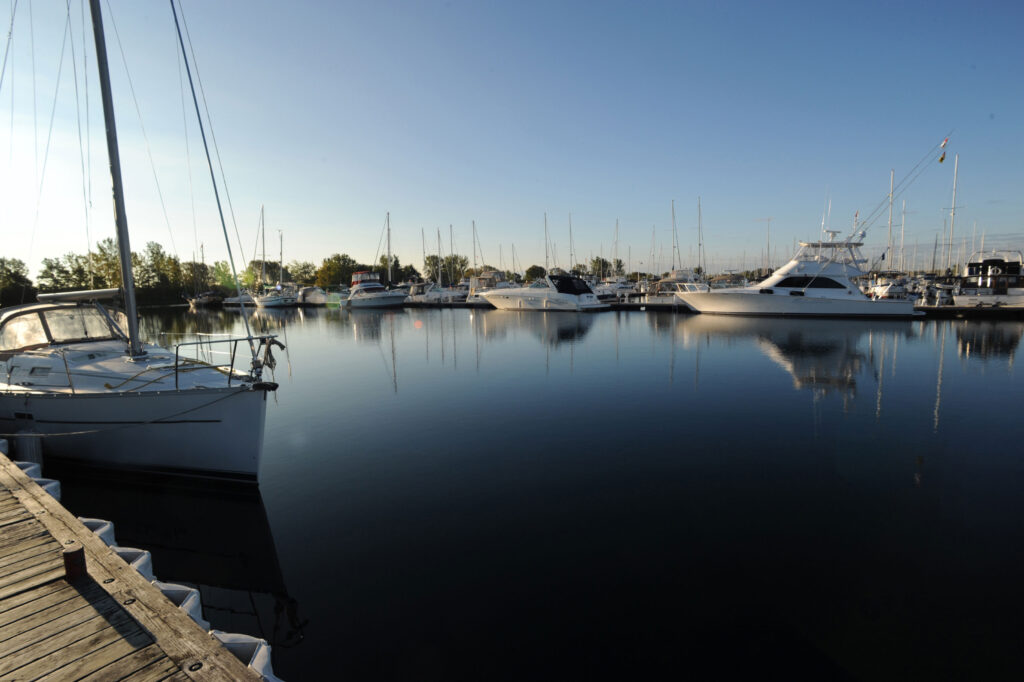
xmin=676 ymin=231 xmax=915 ymax=317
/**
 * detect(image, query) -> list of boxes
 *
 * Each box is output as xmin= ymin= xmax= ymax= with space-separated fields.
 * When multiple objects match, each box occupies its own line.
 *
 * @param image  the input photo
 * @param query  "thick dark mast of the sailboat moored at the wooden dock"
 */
xmin=89 ymin=0 xmax=145 ymax=357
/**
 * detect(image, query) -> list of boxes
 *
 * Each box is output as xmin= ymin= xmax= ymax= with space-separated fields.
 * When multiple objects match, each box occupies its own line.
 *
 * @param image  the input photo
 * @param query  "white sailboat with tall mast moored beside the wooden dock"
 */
xmin=0 ymin=0 xmax=280 ymax=480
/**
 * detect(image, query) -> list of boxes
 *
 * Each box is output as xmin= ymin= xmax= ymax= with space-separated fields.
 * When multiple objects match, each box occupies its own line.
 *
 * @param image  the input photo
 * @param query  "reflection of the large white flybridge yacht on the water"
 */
xmin=678 ymin=315 xmax=914 ymax=401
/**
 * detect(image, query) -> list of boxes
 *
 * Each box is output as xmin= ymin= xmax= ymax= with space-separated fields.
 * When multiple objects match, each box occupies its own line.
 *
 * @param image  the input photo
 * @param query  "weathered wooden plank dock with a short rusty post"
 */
xmin=0 ymin=455 xmax=260 ymax=682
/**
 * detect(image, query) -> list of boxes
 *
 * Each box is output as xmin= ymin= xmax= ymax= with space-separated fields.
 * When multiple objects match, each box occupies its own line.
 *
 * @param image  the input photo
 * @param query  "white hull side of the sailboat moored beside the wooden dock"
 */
xmin=0 ymin=386 xmax=266 ymax=482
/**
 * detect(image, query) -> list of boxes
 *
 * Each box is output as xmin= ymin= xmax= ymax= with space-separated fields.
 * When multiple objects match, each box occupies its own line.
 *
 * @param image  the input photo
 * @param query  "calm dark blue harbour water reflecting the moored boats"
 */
xmin=56 ymin=310 xmax=1024 ymax=681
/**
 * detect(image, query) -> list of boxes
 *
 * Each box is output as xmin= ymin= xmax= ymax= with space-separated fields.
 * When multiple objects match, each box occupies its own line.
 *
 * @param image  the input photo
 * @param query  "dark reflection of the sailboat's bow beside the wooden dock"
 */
xmin=47 ymin=468 xmax=305 ymax=648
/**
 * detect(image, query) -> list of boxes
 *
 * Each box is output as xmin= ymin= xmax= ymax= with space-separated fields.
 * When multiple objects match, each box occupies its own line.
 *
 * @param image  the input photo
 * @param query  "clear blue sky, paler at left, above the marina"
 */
xmin=0 ymin=0 xmax=1024 ymax=278
